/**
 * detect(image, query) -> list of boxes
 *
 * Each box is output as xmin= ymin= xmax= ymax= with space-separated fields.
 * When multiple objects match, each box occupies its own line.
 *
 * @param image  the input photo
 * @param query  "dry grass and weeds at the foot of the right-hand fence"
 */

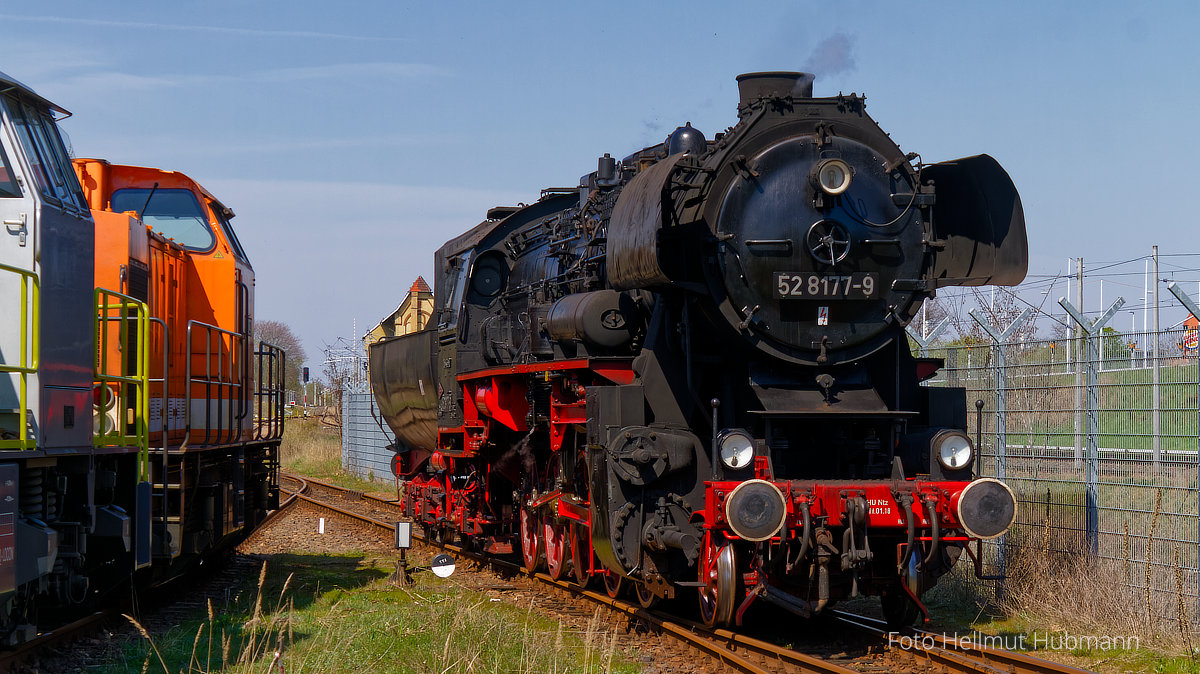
xmin=924 ymin=510 xmax=1200 ymax=674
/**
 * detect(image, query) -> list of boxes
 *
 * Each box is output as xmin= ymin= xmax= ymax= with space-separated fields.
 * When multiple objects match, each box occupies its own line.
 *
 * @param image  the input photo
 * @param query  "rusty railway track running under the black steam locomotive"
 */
xmin=281 ymin=476 xmax=1086 ymax=674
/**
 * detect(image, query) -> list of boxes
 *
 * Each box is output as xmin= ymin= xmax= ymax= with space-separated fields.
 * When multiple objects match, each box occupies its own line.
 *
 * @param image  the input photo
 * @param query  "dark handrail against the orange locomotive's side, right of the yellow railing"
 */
xmin=184 ymin=320 xmax=245 ymax=445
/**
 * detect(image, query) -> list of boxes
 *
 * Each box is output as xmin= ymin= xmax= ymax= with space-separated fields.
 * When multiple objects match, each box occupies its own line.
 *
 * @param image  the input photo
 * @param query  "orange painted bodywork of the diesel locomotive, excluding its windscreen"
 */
xmin=74 ymin=160 xmax=254 ymax=446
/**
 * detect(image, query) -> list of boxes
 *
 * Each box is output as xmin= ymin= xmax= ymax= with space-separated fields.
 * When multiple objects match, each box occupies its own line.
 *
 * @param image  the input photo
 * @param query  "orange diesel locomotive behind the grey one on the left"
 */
xmin=74 ymin=158 xmax=283 ymax=555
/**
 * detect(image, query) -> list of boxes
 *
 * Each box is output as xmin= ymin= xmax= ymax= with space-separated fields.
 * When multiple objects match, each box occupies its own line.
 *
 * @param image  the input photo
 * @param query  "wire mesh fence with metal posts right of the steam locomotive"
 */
xmin=926 ymin=325 xmax=1200 ymax=620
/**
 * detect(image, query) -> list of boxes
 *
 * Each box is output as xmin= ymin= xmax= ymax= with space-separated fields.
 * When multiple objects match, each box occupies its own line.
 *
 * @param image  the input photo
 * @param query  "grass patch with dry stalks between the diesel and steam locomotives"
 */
xmin=108 ymin=555 xmax=637 ymax=674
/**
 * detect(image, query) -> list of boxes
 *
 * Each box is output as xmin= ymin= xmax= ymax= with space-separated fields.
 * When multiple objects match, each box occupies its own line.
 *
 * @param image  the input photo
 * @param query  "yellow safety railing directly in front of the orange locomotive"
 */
xmin=94 ymin=288 xmax=151 ymax=481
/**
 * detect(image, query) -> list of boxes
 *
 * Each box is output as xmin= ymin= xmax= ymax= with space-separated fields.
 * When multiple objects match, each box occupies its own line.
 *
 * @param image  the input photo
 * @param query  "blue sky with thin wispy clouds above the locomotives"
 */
xmin=0 ymin=0 xmax=1200 ymax=365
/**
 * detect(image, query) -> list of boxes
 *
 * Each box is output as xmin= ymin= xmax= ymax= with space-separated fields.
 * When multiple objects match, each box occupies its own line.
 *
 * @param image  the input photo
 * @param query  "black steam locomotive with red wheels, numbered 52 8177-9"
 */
xmin=370 ymin=72 xmax=1028 ymax=625
